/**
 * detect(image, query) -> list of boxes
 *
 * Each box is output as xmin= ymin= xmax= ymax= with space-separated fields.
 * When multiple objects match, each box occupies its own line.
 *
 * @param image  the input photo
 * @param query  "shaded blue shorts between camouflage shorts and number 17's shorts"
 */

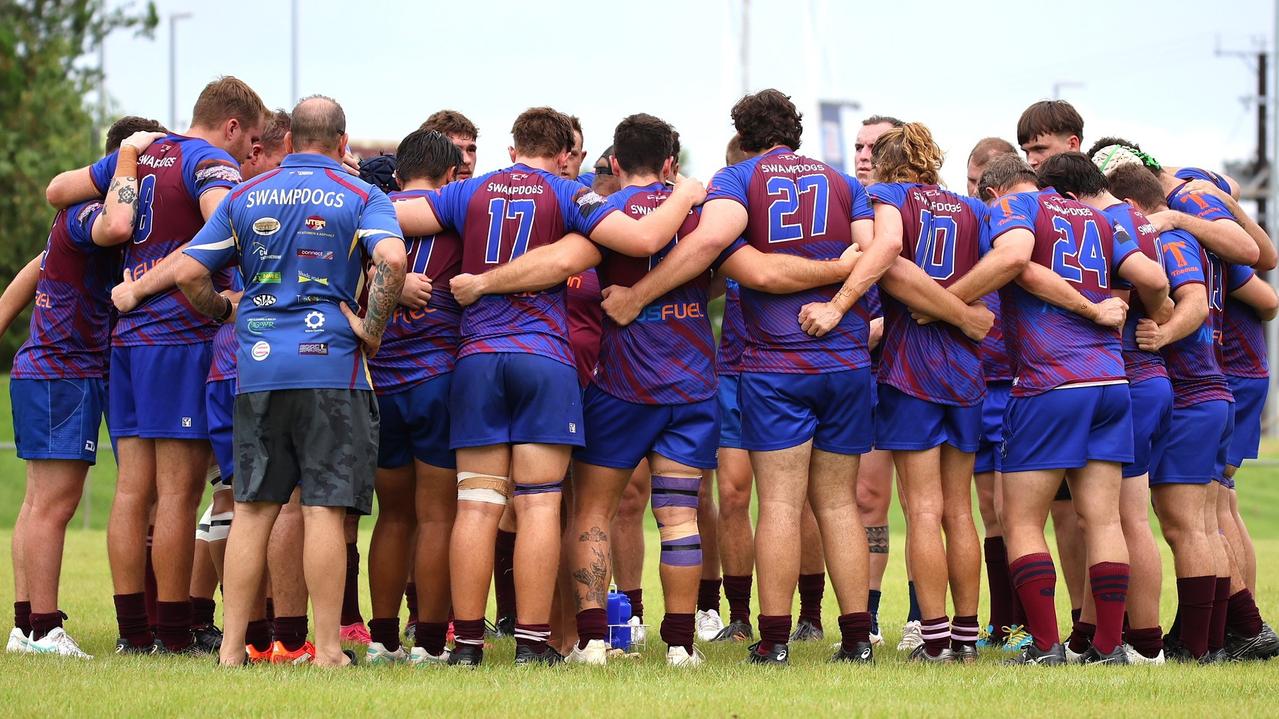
xmin=377 ymin=372 xmax=458 ymax=470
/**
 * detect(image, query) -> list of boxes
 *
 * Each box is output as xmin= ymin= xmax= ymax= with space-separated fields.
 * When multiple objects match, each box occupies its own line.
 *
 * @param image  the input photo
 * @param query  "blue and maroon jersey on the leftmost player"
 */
xmin=13 ymin=200 xmax=120 ymax=380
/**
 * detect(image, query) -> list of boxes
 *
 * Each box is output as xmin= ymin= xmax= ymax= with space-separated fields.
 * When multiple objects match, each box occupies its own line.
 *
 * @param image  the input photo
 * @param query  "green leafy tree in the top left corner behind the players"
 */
xmin=0 ymin=0 xmax=157 ymax=367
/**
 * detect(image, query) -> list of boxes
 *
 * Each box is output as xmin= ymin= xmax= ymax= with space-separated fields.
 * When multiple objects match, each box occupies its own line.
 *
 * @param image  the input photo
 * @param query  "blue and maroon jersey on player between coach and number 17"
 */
xmin=370 ymin=189 xmax=462 ymax=394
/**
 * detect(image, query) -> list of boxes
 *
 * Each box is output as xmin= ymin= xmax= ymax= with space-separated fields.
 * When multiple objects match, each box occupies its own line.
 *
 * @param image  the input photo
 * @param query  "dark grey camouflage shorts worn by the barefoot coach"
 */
xmin=234 ymin=389 xmax=379 ymax=514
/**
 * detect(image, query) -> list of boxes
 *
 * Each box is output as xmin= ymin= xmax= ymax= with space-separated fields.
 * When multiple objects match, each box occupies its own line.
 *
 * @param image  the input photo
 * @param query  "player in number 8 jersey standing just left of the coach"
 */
xmin=46 ymin=77 xmax=267 ymax=652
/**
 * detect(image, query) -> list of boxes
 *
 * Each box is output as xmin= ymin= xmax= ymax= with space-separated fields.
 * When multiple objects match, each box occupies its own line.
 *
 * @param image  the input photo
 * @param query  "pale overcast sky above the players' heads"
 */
xmin=97 ymin=0 xmax=1274 ymax=192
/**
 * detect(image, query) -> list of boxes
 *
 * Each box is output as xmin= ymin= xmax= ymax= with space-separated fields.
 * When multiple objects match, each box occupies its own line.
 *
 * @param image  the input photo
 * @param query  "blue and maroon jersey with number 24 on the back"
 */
xmin=990 ymin=189 xmax=1141 ymax=397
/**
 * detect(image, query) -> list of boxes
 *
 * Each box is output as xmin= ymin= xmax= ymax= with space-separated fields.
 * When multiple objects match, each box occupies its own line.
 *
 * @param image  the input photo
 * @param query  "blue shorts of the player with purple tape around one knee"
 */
xmin=573 ymin=384 xmax=720 ymax=470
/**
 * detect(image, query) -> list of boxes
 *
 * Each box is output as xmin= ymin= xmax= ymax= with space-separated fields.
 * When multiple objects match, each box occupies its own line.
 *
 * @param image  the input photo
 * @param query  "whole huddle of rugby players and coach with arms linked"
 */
xmin=0 ymin=78 xmax=1279 ymax=667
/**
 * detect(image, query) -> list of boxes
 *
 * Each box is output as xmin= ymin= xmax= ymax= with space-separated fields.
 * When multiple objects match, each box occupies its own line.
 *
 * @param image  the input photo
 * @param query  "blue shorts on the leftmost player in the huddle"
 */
xmin=9 ymin=377 xmax=106 ymax=464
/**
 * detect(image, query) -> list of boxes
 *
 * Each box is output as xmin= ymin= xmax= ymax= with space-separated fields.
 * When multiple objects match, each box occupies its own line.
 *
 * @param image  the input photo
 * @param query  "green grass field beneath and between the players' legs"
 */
xmin=0 ymin=383 xmax=1279 ymax=718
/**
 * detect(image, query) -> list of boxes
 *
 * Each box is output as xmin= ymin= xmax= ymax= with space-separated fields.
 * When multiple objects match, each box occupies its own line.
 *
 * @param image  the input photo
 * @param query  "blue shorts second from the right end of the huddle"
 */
xmin=1150 ymin=399 xmax=1232 ymax=486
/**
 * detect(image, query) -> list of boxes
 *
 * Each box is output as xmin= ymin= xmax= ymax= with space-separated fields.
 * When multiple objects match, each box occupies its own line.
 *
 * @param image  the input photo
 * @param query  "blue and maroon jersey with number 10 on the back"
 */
xmin=867 ymin=183 xmax=989 ymax=407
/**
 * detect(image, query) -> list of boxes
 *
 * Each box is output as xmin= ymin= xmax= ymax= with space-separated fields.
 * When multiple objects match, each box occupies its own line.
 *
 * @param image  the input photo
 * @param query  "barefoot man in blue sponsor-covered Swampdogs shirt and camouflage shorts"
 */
xmin=174 ymin=96 xmax=405 ymax=667
